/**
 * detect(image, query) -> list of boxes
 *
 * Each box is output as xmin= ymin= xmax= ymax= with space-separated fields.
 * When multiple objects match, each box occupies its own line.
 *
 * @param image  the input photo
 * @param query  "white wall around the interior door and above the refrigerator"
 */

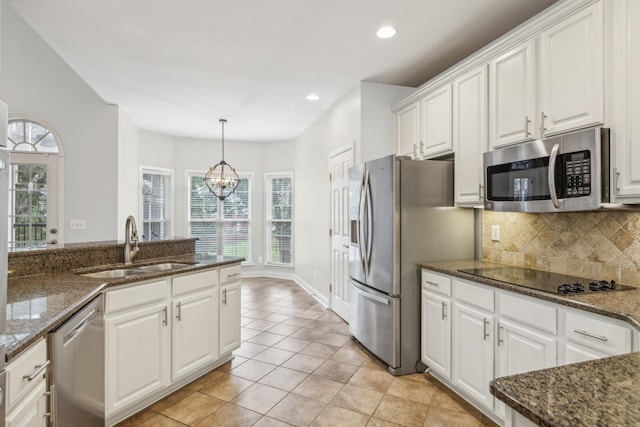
xmin=294 ymin=82 xmax=415 ymax=303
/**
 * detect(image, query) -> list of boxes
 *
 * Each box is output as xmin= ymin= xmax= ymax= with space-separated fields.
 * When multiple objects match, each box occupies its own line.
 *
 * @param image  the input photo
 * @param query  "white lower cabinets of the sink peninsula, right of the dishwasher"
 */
xmin=105 ymin=265 xmax=240 ymax=423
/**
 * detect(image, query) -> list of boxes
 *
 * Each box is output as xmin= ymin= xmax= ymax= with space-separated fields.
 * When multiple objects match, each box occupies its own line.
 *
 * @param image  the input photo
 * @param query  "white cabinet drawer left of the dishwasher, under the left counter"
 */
xmin=6 ymin=339 xmax=47 ymax=412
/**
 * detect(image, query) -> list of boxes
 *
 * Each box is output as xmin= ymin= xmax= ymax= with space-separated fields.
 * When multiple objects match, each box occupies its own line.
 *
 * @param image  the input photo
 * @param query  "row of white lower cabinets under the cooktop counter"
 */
xmin=421 ymin=270 xmax=639 ymax=426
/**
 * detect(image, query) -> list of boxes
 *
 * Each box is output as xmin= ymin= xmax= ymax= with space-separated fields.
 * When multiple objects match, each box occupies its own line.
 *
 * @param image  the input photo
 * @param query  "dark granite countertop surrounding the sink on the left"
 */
xmin=0 ymin=254 xmax=243 ymax=361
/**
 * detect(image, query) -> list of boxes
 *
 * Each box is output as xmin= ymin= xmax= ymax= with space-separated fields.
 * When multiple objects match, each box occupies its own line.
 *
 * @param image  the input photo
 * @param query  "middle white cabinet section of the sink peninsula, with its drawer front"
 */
xmin=171 ymin=270 xmax=220 ymax=381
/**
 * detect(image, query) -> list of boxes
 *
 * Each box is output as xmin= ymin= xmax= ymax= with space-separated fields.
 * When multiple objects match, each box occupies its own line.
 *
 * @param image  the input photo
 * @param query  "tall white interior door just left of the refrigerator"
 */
xmin=329 ymin=147 xmax=353 ymax=321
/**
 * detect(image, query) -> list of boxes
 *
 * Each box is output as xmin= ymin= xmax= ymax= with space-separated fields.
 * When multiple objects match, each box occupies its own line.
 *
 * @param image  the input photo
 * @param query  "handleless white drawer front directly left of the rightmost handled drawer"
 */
xmin=499 ymin=293 xmax=558 ymax=335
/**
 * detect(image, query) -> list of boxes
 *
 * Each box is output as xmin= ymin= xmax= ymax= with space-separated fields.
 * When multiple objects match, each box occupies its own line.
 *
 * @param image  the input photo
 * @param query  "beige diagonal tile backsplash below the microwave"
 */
xmin=482 ymin=211 xmax=640 ymax=287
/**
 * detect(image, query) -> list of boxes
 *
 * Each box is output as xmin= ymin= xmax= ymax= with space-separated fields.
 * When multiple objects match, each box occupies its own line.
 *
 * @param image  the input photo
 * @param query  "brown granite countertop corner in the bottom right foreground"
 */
xmin=491 ymin=353 xmax=640 ymax=427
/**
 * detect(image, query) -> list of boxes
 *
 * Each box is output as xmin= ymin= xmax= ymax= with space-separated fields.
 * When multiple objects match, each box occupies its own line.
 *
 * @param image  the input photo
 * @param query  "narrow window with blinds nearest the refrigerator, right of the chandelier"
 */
xmin=265 ymin=173 xmax=293 ymax=267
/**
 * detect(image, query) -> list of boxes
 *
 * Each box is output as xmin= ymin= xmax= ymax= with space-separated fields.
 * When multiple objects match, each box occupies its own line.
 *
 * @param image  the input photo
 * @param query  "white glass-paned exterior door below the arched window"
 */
xmin=8 ymin=152 xmax=60 ymax=249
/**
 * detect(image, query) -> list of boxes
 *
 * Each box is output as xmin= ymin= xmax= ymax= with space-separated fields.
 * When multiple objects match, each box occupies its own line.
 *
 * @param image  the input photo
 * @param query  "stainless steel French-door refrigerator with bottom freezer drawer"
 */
xmin=349 ymin=156 xmax=474 ymax=375
